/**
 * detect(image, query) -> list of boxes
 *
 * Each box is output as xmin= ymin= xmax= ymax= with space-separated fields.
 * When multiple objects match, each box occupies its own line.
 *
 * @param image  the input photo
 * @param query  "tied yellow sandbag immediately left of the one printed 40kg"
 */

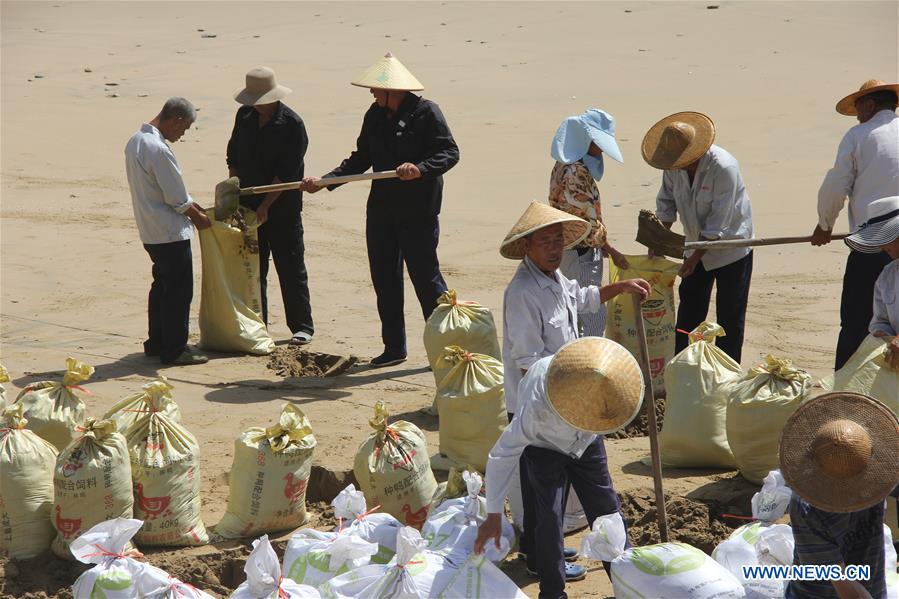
xmin=52 ymin=418 xmax=134 ymax=559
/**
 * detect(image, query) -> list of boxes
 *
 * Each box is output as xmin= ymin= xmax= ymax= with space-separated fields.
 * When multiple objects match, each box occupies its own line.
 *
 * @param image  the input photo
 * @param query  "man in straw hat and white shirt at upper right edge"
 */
xmin=812 ymin=79 xmax=899 ymax=370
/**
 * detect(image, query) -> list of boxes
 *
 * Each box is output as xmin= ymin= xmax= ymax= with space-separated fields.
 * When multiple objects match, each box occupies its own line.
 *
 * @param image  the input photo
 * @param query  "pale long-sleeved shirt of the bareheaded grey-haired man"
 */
xmin=125 ymin=123 xmax=194 ymax=244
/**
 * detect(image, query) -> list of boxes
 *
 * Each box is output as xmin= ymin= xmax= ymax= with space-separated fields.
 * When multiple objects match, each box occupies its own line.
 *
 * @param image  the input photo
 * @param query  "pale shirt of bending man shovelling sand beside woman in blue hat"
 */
xmin=656 ymin=145 xmax=753 ymax=270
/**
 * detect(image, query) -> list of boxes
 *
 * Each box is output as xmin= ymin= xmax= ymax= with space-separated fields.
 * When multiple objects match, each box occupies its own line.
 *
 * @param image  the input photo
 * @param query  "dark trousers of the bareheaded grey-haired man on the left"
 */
xmin=144 ymin=239 xmax=194 ymax=364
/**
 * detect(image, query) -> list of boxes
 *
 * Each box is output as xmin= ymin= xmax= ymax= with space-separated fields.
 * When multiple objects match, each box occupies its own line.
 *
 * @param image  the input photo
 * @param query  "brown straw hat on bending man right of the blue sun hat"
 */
xmin=640 ymin=112 xmax=715 ymax=171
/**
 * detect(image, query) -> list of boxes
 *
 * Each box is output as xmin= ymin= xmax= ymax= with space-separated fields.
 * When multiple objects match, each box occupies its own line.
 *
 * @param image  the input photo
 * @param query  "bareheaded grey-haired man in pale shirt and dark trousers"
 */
xmin=125 ymin=97 xmax=210 ymax=365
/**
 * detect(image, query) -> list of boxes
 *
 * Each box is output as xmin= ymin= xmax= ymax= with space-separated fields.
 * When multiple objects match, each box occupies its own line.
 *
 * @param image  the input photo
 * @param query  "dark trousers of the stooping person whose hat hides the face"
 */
xmin=520 ymin=437 xmax=630 ymax=599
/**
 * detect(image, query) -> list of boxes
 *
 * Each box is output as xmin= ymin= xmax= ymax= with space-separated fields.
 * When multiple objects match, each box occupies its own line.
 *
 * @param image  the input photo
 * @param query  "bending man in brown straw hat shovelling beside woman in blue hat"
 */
xmin=642 ymin=112 xmax=753 ymax=362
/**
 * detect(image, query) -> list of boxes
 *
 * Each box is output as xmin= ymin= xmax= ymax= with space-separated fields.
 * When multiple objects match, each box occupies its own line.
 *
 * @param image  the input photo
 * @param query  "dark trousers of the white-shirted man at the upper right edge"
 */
xmin=834 ymin=250 xmax=890 ymax=370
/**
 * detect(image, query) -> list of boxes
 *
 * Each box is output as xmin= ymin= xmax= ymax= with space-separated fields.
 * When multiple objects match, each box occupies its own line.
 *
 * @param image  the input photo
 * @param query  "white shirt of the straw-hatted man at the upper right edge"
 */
xmin=818 ymin=110 xmax=899 ymax=232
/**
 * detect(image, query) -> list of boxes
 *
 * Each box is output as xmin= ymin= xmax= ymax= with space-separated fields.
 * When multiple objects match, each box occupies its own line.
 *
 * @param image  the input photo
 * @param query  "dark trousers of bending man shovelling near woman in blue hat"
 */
xmin=674 ymin=252 xmax=752 ymax=363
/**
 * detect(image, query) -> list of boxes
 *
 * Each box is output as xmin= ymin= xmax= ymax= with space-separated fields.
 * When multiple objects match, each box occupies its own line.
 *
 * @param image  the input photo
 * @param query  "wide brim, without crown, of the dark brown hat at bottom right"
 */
xmin=780 ymin=392 xmax=899 ymax=513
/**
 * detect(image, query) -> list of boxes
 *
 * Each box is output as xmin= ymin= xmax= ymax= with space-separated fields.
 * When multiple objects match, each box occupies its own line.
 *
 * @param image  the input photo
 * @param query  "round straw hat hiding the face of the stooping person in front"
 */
xmin=546 ymin=337 xmax=643 ymax=435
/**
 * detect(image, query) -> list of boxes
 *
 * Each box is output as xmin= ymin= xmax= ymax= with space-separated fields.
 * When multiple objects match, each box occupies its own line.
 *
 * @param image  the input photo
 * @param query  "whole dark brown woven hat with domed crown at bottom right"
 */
xmin=780 ymin=392 xmax=899 ymax=513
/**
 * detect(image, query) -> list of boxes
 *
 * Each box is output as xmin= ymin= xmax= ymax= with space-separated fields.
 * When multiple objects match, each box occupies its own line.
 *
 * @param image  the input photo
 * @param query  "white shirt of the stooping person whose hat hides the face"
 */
xmin=486 ymin=356 xmax=598 ymax=514
